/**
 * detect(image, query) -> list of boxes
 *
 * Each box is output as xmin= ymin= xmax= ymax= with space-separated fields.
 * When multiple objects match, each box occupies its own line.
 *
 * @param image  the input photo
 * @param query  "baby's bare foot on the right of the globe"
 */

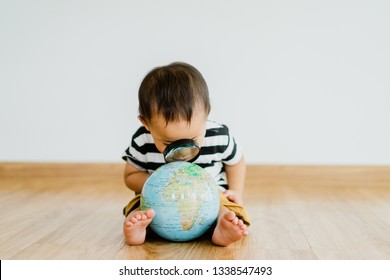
xmin=211 ymin=211 xmax=248 ymax=246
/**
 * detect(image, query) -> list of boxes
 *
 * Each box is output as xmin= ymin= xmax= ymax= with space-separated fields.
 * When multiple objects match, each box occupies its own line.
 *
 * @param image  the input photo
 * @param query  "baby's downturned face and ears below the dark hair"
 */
xmin=143 ymin=110 xmax=207 ymax=153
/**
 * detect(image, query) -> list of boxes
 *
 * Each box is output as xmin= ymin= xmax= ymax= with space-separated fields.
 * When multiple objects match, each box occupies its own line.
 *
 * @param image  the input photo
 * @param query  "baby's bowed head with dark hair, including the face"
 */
xmin=138 ymin=62 xmax=211 ymax=155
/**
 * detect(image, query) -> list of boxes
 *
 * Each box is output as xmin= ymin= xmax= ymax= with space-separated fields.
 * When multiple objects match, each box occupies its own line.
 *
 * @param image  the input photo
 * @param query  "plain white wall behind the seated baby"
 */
xmin=0 ymin=0 xmax=390 ymax=165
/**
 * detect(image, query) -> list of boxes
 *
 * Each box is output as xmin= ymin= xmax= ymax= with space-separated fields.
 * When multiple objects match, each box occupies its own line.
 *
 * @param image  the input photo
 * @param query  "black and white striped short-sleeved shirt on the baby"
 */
xmin=122 ymin=121 xmax=242 ymax=188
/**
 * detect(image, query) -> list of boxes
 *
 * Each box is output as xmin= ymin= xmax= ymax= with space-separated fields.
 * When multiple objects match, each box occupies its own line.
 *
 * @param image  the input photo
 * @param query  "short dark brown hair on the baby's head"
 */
xmin=138 ymin=62 xmax=211 ymax=124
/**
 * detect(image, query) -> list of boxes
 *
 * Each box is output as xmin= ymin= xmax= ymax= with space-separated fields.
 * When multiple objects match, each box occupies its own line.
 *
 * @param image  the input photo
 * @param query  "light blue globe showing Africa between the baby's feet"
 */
xmin=141 ymin=162 xmax=219 ymax=241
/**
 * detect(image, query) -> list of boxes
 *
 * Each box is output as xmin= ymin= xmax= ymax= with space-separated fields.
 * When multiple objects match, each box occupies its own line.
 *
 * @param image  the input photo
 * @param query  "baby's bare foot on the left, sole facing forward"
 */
xmin=123 ymin=208 xmax=155 ymax=245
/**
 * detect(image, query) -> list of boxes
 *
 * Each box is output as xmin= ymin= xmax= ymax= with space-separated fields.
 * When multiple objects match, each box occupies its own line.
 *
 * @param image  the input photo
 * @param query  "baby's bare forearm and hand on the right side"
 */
xmin=225 ymin=157 xmax=246 ymax=204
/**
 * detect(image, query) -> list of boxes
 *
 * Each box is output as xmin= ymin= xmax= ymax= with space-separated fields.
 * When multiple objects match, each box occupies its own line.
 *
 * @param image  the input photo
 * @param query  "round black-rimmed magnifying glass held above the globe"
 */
xmin=163 ymin=139 xmax=200 ymax=162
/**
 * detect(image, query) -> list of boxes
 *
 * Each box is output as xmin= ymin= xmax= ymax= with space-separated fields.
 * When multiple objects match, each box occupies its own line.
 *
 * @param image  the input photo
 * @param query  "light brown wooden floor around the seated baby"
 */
xmin=0 ymin=163 xmax=390 ymax=260
